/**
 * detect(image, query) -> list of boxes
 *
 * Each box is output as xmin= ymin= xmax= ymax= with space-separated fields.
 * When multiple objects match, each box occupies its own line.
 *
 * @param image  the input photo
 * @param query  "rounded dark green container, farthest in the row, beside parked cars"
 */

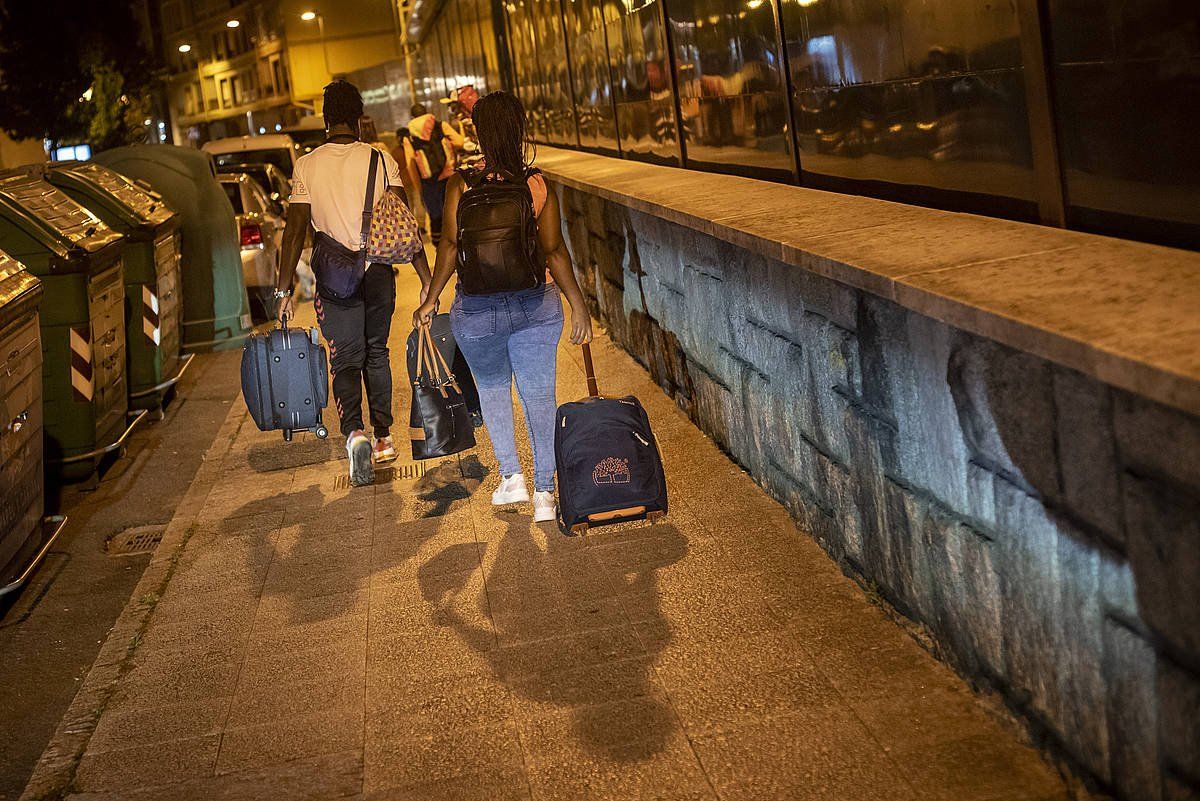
xmin=92 ymin=145 xmax=251 ymax=353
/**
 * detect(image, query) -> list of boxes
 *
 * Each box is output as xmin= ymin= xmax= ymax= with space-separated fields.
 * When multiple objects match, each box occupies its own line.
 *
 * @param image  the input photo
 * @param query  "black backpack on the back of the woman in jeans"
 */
xmin=458 ymin=169 xmax=546 ymax=295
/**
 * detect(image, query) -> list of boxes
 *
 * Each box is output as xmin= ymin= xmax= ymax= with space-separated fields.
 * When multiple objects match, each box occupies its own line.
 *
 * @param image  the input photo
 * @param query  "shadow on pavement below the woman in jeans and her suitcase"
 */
xmin=418 ymin=514 xmax=688 ymax=763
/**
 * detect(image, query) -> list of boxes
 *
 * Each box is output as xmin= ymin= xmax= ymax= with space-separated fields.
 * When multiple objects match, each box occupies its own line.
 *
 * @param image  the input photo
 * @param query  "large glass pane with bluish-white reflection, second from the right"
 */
xmin=782 ymin=0 xmax=1036 ymax=218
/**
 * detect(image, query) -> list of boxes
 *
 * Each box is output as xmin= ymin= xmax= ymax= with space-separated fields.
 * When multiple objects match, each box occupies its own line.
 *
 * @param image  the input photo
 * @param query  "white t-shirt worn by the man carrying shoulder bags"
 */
xmin=289 ymin=141 xmax=403 ymax=251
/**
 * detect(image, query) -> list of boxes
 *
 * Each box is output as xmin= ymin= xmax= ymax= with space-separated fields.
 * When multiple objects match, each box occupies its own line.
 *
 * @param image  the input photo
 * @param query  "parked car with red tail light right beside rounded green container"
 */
xmin=217 ymin=173 xmax=283 ymax=320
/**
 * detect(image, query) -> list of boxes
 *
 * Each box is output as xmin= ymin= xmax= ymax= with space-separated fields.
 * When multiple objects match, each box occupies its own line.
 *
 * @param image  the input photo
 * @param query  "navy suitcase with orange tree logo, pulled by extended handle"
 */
xmin=554 ymin=344 xmax=667 ymax=534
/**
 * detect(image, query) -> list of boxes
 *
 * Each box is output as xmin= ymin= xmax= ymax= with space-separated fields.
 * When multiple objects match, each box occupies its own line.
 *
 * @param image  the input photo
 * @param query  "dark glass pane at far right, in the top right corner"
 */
xmin=1050 ymin=0 xmax=1200 ymax=248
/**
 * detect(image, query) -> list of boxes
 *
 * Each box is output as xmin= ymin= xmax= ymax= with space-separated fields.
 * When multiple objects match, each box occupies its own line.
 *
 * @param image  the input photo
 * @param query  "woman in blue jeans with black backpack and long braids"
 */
xmin=413 ymin=91 xmax=592 ymax=522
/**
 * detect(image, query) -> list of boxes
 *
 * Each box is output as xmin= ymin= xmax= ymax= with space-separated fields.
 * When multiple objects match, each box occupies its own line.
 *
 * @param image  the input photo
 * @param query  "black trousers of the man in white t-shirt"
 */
xmin=313 ymin=264 xmax=396 ymax=436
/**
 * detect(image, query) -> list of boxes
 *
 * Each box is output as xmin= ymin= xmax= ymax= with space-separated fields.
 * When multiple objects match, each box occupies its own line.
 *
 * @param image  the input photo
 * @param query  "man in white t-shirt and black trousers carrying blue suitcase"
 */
xmin=275 ymin=80 xmax=430 ymax=484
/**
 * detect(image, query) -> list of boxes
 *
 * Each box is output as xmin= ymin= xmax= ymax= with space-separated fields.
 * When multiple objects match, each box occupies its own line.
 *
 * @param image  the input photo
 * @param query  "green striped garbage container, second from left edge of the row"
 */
xmin=0 ymin=170 xmax=145 ymax=480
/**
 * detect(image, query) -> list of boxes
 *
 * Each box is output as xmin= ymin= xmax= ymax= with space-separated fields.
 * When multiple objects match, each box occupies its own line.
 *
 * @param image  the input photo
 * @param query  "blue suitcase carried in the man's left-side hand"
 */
xmin=241 ymin=327 xmax=329 ymax=441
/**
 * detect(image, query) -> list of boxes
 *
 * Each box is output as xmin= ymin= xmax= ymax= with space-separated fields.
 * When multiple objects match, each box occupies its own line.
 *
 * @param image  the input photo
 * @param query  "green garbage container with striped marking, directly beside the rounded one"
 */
xmin=41 ymin=162 xmax=192 ymax=409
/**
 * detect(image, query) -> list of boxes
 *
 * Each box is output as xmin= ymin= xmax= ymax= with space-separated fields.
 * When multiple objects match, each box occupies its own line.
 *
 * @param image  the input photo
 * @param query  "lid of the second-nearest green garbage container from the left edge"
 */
xmin=0 ymin=173 xmax=121 ymax=253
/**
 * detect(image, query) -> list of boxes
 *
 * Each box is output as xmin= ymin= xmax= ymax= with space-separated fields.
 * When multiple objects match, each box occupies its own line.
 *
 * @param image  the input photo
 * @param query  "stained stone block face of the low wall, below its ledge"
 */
xmin=556 ymin=186 xmax=1200 ymax=801
